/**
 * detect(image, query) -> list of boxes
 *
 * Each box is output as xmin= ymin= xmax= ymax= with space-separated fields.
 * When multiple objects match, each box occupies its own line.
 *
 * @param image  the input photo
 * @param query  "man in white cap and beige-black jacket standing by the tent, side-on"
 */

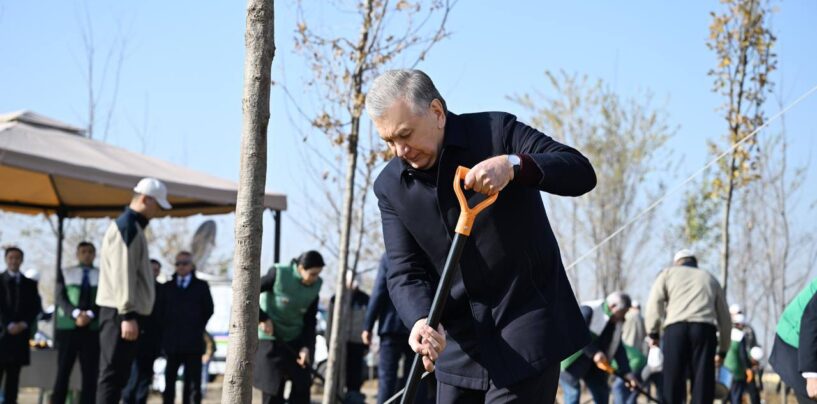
xmin=96 ymin=178 xmax=171 ymax=404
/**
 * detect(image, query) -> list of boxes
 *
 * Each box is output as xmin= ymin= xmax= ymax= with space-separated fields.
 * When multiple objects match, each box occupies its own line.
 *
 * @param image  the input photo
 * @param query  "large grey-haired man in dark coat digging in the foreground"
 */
xmin=366 ymin=70 xmax=596 ymax=403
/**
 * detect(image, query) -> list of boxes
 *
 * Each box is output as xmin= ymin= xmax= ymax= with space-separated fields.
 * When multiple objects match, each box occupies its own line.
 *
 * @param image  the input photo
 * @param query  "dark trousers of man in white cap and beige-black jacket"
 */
xmin=96 ymin=307 xmax=141 ymax=404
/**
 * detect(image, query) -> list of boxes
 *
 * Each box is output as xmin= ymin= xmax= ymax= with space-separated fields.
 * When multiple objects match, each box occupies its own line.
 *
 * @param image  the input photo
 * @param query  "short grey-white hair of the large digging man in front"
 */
xmin=366 ymin=69 xmax=448 ymax=118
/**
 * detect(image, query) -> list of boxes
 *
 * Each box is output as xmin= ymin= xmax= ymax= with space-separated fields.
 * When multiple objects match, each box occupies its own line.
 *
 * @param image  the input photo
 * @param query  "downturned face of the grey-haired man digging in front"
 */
xmin=372 ymin=99 xmax=445 ymax=170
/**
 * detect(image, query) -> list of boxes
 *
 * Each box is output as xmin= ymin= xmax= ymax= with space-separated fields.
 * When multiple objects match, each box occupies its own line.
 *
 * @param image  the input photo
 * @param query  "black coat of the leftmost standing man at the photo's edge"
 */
xmin=0 ymin=271 xmax=42 ymax=365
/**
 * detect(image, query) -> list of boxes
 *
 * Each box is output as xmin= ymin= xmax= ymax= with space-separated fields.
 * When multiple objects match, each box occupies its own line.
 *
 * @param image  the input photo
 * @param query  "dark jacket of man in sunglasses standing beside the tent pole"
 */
xmin=161 ymin=271 xmax=213 ymax=355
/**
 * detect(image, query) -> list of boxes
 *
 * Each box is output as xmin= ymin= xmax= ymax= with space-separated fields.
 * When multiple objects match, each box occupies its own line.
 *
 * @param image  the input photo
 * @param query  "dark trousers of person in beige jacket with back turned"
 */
xmin=663 ymin=323 xmax=718 ymax=404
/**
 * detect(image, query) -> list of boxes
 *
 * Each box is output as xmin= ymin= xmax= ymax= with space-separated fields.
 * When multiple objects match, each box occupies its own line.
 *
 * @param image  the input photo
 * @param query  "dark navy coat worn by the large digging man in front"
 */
xmin=374 ymin=112 xmax=596 ymax=390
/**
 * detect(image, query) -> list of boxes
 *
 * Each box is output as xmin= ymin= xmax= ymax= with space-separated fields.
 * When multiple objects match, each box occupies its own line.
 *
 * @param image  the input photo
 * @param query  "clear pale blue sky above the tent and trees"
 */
xmin=0 ymin=0 xmax=817 ymax=296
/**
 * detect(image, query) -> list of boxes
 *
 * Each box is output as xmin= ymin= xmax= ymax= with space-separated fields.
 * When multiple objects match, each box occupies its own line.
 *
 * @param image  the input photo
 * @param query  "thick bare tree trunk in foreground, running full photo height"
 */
xmin=221 ymin=0 xmax=275 ymax=404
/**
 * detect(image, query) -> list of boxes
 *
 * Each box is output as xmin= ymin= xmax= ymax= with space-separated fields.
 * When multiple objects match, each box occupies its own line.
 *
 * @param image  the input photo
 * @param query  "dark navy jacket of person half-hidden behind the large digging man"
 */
xmin=363 ymin=254 xmax=409 ymax=338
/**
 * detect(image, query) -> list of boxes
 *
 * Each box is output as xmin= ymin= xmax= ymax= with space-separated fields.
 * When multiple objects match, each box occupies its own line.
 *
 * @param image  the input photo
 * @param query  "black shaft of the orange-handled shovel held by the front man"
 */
xmin=400 ymin=233 xmax=468 ymax=404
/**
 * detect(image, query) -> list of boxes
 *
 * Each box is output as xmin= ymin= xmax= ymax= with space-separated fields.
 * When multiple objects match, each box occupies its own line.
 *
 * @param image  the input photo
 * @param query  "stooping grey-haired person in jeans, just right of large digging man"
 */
xmin=559 ymin=292 xmax=638 ymax=404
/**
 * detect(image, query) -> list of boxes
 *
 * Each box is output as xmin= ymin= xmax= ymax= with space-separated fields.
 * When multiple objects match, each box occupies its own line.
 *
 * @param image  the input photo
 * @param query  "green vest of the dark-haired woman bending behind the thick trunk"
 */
xmin=258 ymin=263 xmax=323 ymax=342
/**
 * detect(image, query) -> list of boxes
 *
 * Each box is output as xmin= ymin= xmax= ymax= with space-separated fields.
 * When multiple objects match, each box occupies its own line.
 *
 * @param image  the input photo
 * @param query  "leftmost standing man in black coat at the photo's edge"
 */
xmin=0 ymin=247 xmax=42 ymax=404
